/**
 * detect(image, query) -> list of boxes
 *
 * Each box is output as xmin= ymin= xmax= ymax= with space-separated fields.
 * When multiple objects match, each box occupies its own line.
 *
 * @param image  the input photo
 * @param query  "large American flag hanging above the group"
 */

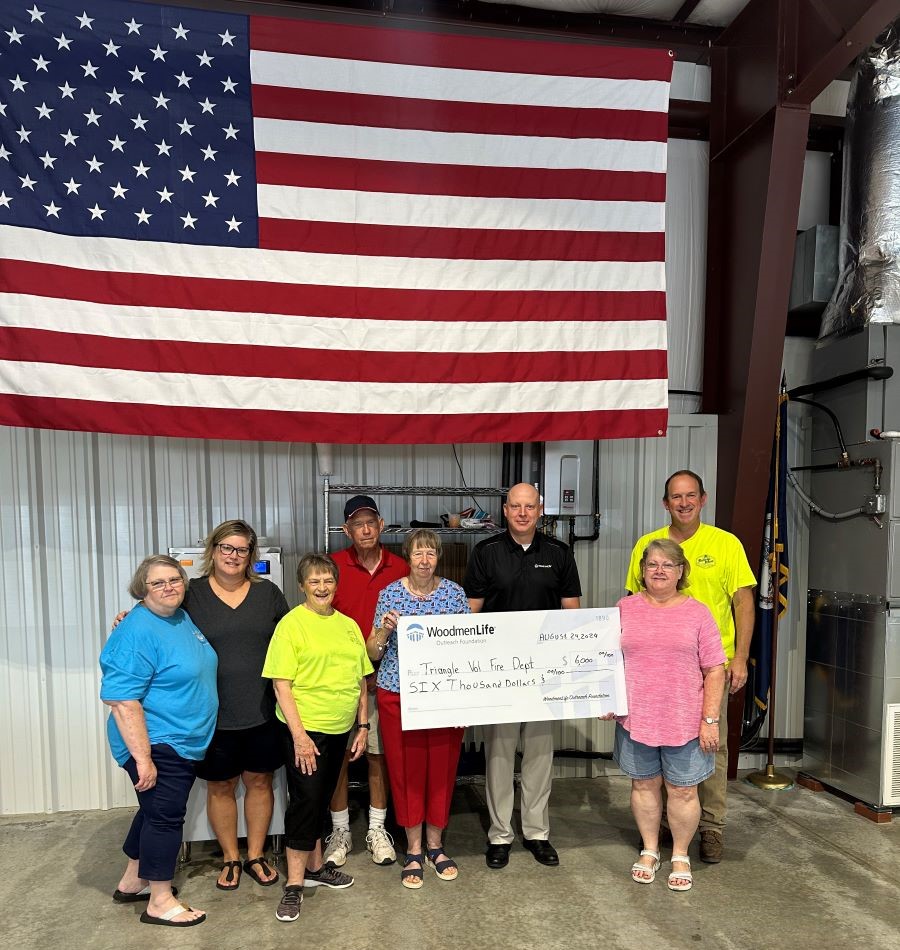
xmin=0 ymin=0 xmax=671 ymax=443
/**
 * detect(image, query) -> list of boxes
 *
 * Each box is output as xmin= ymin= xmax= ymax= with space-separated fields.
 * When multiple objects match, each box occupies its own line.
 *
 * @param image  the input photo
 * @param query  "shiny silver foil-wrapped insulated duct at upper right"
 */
xmin=820 ymin=21 xmax=900 ymax=337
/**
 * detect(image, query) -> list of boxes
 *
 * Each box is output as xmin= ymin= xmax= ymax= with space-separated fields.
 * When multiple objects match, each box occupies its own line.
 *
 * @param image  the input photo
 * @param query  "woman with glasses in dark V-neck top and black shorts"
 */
xmin=190 ymin=520 xmax=288 ymax=891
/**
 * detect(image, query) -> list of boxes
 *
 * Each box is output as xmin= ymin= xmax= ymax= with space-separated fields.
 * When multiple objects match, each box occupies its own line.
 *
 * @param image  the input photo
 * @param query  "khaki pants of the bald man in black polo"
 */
xmin=485 ymin=722 xmax=553 ymax=844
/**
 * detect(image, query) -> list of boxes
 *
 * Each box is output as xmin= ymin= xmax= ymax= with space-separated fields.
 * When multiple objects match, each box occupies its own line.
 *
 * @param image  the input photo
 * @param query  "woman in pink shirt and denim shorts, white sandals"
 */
xmin=613 ymin=540 xmax=725 ymax=891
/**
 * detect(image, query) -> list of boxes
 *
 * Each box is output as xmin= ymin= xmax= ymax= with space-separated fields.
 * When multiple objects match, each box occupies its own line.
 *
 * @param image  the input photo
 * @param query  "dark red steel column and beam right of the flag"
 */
xmin=703 ymin=0 xmax=900 ymax=778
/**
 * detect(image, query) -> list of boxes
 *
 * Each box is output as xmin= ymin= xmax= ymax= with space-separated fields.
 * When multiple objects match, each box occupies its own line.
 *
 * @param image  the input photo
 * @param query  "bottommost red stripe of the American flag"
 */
xmin=0 ymin=390 xmax=666 ymax=445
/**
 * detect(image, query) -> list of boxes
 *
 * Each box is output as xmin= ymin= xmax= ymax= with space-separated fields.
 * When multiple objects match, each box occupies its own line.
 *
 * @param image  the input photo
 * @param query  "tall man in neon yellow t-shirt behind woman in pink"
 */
xmin=625 ymin=469 xmax=756 ymax=864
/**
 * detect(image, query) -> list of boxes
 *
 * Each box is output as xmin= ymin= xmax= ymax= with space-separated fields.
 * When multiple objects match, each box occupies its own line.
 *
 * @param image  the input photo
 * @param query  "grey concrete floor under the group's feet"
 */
xmin=0 ymin=776 xmax=900 ymax=950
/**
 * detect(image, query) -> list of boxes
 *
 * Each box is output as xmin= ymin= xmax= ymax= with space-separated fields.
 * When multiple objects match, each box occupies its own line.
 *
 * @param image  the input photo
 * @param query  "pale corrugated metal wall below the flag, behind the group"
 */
xmin=0 ymin=416 xmax=716 ymax=814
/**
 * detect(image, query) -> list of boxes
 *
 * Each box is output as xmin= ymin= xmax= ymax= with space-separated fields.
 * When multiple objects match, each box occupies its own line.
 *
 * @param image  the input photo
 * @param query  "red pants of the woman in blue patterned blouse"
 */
xmin=378 ymin=687 xmax=464 ymax=828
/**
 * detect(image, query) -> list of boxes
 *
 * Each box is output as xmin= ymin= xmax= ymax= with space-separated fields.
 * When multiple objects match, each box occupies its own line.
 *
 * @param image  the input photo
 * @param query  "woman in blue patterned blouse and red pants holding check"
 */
xmin=367 ymin=528 xmax=471 ymax=890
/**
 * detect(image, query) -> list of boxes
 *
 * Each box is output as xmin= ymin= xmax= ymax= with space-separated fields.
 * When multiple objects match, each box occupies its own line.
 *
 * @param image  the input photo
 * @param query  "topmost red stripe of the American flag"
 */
xmin=250 ymin=17 xmax=672 ymax=83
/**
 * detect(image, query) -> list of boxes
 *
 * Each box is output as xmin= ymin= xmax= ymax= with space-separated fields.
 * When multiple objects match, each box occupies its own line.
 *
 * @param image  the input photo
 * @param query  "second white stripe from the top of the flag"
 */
xmin=253 ymin=118 xmax=666 ymax=172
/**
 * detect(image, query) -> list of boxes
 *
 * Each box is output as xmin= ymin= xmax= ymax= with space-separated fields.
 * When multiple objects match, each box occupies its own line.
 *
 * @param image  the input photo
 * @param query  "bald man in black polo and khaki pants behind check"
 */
xmin=463 ymin=484 xmax=581 ymax=869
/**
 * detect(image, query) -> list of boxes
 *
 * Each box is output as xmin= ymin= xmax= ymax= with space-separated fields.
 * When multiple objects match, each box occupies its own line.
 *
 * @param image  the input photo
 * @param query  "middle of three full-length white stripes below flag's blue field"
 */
xmin=2 ymin=294 xmax=666 ymax=354
